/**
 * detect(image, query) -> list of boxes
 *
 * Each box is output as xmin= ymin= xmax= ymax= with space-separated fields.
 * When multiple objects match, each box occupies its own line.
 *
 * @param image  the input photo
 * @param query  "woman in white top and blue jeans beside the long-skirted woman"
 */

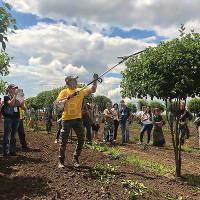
xmin=140 ymin=106 xmax=153 ymax=144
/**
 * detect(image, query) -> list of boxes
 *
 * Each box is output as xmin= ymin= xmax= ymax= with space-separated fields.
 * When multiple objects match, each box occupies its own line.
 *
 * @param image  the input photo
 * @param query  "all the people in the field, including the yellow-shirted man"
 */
xmin=0 ymin=75 xmax=194 ymax=168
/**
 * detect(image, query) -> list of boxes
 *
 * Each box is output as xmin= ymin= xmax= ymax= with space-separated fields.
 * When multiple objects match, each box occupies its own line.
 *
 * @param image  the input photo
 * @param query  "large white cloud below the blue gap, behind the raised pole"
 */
xmin=6 ymin=23 xmax=155 ymax=98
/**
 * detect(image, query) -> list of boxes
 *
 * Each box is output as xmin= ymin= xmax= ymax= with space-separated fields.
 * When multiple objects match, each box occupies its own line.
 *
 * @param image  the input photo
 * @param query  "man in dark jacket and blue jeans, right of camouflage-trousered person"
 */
xmin=119 ymin=100 xmax=132 ymax=144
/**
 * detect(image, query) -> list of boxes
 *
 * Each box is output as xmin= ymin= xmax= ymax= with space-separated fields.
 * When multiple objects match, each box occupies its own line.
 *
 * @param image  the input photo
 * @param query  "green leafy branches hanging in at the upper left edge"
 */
xmin=0 ymin=2 xmax=17 ymax=93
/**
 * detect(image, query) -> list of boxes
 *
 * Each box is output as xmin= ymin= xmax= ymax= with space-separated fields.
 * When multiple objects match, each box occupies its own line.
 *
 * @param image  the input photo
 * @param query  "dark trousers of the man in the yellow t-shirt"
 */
xmin=59 ymin=119 xmax=84 ymax=162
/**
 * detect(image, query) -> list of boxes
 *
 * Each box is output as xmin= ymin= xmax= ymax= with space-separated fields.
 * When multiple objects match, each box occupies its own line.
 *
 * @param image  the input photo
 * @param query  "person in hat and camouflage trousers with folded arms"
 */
xmin=103 ymin=103 xmax=114 ymax=144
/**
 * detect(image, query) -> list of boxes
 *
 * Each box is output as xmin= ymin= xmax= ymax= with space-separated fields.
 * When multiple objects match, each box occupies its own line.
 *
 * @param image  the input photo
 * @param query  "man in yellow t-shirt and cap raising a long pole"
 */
xmin=57 ymin=74 xmax=98 ymax=168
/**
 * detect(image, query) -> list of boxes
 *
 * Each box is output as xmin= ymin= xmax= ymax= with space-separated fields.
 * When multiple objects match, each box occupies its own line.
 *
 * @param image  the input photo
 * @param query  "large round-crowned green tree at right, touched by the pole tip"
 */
xmin=121 ymin=25 xmax=200 ymax=176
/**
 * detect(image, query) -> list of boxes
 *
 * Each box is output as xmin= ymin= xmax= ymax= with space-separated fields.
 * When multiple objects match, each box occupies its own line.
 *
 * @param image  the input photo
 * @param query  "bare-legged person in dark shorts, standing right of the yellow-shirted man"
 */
xmin=91 ymin=104 xmax=101 ymax=142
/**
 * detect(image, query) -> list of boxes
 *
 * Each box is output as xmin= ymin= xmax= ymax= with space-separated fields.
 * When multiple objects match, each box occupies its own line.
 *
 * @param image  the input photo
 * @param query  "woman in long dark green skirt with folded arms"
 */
xmin=152 ymin=108 xmax=165 ymax=147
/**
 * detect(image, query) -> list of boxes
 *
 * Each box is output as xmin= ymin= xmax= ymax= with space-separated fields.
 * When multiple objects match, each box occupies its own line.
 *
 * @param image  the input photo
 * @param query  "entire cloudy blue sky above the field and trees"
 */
xmin=1 ymin=0 xmax=200 ymax=102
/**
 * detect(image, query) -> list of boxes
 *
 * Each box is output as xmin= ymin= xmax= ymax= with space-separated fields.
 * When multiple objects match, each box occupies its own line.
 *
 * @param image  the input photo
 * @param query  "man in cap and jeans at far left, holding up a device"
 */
xmin=2 ymin=84 xmax=25 ymax=157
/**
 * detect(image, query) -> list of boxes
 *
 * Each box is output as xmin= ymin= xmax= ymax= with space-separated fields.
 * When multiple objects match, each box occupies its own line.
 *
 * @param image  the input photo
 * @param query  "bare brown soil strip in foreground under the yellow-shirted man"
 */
xmin=0 ymin=130 xmax=200 ymax=200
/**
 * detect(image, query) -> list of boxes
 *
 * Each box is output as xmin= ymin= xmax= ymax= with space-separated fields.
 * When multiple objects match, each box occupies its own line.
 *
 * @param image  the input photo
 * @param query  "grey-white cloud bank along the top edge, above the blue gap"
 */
xmin=7 ymin=0 xmax=200 ymax=38
